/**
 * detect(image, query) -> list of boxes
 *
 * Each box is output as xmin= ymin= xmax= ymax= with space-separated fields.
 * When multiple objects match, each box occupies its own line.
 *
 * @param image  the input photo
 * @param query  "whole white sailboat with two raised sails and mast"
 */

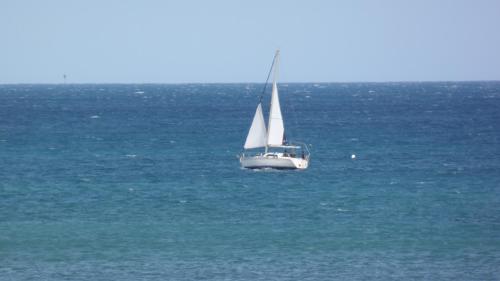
xmin=239 ymin=50 xmax=310 ymax=170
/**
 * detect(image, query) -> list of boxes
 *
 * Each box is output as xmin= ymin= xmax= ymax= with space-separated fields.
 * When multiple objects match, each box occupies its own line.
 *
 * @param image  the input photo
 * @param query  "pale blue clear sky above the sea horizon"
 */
xmin=0 ymin=0 xmax=500 ymax=84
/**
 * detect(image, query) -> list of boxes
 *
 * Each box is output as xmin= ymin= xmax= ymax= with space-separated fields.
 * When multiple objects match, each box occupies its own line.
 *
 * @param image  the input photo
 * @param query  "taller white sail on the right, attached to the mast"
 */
xmin=267 ymin=81 xmax=285 ymax=146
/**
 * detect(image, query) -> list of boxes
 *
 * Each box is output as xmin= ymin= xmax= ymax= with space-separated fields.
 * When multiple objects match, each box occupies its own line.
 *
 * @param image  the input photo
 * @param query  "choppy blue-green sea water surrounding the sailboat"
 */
xmin=0 ymin=82 xmax=500 ymax=280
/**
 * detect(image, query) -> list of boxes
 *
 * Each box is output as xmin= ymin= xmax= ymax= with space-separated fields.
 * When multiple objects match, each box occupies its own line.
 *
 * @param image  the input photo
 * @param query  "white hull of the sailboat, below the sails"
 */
xmin=240 ymin=154 xmax=309 ymax=170
